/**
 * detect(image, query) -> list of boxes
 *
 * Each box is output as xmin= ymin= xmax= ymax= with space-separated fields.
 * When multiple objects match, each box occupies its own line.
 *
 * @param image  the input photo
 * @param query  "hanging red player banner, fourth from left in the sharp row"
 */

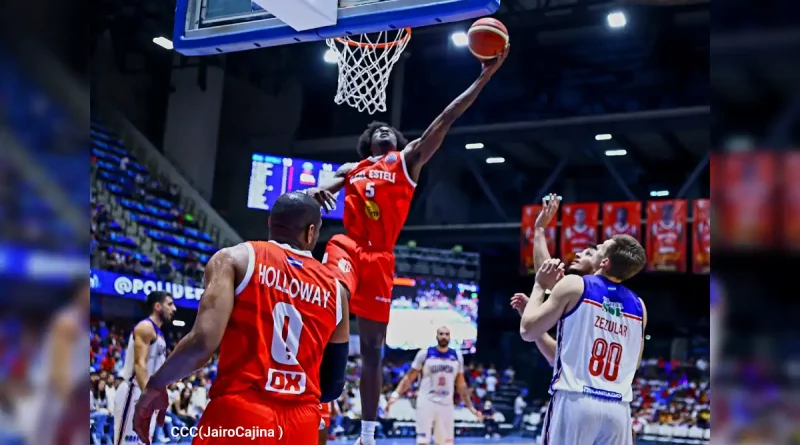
xmin=646 ymin=199 xmax=686 ymax=272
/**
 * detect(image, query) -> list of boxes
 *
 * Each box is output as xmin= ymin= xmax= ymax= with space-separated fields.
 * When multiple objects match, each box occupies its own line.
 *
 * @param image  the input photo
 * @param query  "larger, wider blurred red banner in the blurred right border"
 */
xmin=712 ymin=152 xmax=777 ymax=248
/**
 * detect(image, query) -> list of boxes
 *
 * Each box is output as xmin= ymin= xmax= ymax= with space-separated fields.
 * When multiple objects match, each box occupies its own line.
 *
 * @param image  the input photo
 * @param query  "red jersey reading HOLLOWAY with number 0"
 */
xmin=209 ymin=241 xmax=342 ymax=405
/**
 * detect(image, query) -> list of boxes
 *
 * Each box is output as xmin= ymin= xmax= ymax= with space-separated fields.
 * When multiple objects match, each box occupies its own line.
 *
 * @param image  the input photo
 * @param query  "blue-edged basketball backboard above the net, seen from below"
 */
xmin=173 ymin=0 xmax=500 ymax=56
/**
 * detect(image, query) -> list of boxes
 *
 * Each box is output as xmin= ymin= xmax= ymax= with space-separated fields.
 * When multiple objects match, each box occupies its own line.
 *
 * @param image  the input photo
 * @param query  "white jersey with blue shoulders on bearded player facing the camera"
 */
xmin=411 ymin=346 xmax=464 ymax=405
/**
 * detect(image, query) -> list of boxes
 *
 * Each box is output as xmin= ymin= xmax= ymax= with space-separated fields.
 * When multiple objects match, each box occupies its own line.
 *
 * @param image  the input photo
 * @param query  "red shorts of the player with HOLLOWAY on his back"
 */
xmin=192 ymin=393 xmax=320 ymax=445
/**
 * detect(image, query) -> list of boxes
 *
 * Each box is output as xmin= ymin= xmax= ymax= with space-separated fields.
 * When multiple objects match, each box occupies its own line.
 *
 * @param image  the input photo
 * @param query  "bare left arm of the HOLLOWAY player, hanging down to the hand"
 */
xmin=133 ymin=244 xmax=244 ymax=445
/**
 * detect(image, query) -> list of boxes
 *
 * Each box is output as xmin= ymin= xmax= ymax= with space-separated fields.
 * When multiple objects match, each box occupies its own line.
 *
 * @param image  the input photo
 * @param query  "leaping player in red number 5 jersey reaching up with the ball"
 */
xmin=307 ymin=47 xmax=508 ymax=445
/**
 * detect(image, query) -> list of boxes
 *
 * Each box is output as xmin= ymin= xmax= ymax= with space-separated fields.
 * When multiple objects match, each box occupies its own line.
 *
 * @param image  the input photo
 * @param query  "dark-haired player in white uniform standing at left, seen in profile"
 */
xmin=114 ymin=291 xmax=176 ymax=445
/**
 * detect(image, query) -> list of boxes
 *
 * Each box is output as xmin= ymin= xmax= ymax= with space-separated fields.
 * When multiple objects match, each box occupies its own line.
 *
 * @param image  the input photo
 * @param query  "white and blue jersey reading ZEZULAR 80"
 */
xmin=550 ymin=275 xmax=644 ymax=402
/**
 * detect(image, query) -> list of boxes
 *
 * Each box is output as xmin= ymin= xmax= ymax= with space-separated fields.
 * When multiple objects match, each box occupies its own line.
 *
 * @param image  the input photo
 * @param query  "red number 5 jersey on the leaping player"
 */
xmin=344 ymin=151 xmax=417 ymax=252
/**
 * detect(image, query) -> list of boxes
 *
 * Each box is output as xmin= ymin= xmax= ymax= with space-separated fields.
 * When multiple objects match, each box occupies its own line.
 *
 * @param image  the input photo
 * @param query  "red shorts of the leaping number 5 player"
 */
xmin=325 ymin=235 xmax=394 ymax=323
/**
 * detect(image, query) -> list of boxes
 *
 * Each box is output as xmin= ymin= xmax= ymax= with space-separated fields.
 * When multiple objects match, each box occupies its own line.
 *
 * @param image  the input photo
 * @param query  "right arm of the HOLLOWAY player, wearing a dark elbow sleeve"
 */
xmin=319 ymin=283 xmax=350 ymax=403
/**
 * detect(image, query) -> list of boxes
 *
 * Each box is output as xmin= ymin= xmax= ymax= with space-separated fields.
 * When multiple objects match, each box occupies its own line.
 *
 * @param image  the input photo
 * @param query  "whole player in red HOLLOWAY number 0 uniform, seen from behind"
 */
xmin=134 ymin=192 xmax=350 ymax=445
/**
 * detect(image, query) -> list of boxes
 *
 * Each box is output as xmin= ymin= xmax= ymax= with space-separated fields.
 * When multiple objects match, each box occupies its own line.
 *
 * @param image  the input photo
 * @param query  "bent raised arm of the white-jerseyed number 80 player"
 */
xmin=519 ymin=260 xmax=583 ymax=342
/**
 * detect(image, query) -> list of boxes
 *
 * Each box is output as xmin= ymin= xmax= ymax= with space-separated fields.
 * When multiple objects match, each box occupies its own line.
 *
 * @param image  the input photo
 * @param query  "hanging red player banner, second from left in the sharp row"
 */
xmin=561 ymin=202 xmax=600 ymax=264
